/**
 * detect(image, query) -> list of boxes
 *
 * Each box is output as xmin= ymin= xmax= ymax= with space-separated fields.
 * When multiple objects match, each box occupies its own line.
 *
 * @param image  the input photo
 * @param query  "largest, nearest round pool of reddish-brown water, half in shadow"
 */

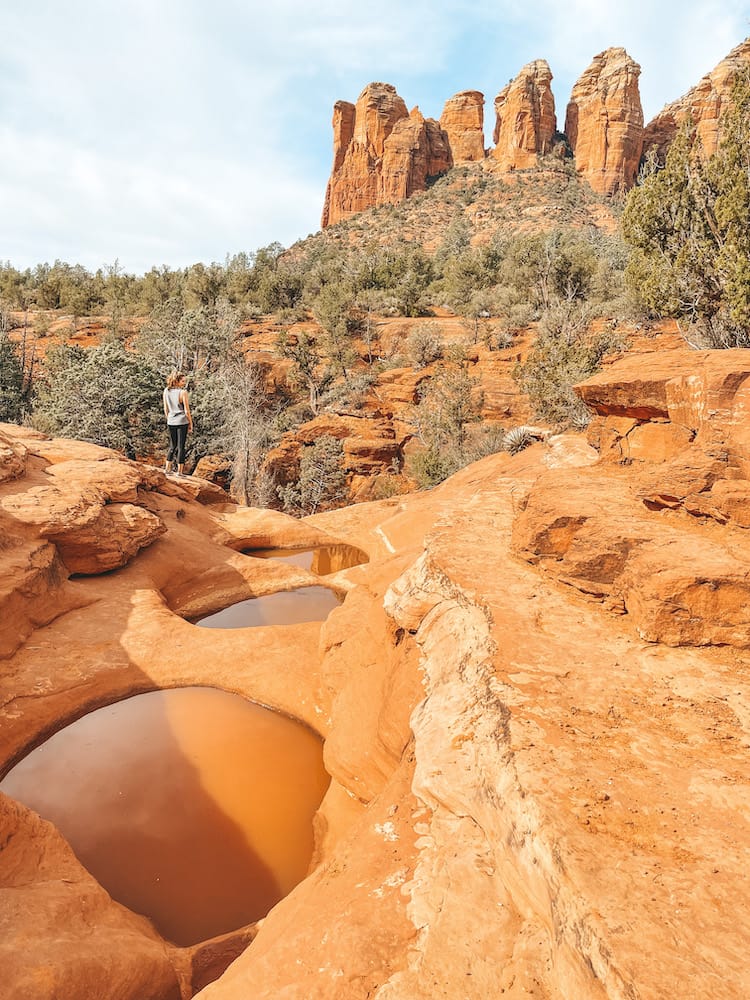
xmin=0 ymin=688 xmax=329 ymax=945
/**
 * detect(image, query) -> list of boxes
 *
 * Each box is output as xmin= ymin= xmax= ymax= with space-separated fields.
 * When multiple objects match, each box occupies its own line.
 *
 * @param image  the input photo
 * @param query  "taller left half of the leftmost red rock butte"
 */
xmin=321 ymin=83 xmax=408 ymax=227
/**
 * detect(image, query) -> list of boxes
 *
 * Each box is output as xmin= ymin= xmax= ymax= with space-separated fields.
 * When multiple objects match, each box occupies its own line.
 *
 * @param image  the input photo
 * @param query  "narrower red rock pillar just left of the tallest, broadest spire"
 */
xmin=492 ymin=59 xmax=557 ymax=170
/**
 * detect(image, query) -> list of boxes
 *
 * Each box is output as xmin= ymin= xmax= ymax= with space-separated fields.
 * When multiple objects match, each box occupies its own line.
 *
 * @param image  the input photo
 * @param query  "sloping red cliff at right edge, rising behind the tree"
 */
xmin=643 ymin=38 xmax=750 ymax=162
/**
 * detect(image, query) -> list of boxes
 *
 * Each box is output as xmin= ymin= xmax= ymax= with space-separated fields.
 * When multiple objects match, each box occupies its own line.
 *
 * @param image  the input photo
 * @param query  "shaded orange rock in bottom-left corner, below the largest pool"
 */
xmin=0 ymin=793 xmax=181 ymax=1000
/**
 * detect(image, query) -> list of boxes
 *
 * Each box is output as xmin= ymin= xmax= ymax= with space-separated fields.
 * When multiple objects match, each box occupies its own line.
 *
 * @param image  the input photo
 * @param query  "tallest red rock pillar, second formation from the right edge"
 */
xmin=565 ymin=48 xmax=643 ymax=194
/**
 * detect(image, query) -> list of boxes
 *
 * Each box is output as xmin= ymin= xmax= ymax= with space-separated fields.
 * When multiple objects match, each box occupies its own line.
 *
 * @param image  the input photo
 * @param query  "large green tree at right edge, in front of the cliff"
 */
xmin=622 ymin=76 xmax=750 ymax=347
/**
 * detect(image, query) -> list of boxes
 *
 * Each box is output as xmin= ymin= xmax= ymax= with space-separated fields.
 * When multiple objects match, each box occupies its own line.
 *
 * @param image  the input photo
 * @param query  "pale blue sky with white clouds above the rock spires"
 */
xmin=0 ymin=0 xmax=750 ymax=273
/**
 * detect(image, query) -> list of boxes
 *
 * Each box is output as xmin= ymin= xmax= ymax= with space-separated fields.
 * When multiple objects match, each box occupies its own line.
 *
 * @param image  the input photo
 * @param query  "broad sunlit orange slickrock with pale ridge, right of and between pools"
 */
xmin=0 ymin=351 xmax=750 ymax=1000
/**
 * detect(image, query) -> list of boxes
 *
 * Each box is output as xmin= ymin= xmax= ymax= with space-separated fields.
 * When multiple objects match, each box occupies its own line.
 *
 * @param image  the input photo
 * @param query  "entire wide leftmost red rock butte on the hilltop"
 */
xmin=321 ymin=83 xmax=453 ymax=227
